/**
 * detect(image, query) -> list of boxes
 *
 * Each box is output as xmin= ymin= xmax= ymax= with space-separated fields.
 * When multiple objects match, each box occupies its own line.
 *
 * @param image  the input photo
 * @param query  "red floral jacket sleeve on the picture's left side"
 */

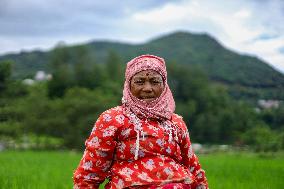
xmin=73 ymin=113 xmax=117 ymax=189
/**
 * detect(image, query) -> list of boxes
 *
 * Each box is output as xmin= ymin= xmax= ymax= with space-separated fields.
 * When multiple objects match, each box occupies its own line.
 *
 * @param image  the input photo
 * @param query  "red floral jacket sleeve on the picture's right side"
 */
xmin=181 ymin=121 xmax=208 ymax=189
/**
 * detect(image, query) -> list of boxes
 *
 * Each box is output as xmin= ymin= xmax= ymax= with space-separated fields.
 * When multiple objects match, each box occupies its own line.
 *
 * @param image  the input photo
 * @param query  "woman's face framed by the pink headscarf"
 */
xmin=130 ymin=70 xmax=164 ymax=102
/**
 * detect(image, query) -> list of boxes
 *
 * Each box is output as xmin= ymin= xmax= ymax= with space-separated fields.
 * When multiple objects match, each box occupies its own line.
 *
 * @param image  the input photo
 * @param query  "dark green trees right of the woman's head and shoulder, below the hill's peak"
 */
xmin=169 ymin=64 xmax=257 ymax=143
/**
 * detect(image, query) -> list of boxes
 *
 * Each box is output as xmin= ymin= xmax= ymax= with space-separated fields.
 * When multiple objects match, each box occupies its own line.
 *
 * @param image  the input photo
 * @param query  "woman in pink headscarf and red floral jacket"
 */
xmin=73 ymin=55 xmax=208 ymax=189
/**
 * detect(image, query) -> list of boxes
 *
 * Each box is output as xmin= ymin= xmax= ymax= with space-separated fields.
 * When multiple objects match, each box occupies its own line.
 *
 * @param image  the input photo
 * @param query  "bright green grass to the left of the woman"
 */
xmin=0 ymin=151 xmax=80 ymax=189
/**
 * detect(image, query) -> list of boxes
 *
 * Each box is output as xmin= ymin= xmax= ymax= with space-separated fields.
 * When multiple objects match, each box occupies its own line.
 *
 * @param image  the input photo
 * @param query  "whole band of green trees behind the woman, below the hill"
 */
xmin=0 ymin=47 xmax=284 ymax=151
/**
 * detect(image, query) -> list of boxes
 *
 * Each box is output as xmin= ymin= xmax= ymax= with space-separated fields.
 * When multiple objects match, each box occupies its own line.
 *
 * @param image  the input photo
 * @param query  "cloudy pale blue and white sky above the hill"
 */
xmin=0 ymin=0 xmax=284 ymax=73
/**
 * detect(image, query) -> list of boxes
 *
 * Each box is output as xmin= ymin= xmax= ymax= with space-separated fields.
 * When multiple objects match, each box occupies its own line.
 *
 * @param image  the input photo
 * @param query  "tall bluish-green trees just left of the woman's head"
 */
xmin=48 ymin=46 xmax=124 ymax=98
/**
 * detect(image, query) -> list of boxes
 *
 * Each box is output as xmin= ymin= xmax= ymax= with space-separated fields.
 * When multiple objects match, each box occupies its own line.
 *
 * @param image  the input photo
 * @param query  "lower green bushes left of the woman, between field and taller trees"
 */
xmin=0 ymin=85 xmax=117 ymax=148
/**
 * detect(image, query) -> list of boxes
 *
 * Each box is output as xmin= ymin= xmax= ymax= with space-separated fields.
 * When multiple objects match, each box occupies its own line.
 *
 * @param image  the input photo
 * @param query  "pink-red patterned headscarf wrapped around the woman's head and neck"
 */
xmin=122 ymin=55 xmax=175 ymax=120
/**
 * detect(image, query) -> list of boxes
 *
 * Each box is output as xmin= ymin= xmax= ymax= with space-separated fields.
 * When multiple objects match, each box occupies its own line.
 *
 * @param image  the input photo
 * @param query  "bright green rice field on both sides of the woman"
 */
xmin=0 ymin=151 xmax=284 ymax=189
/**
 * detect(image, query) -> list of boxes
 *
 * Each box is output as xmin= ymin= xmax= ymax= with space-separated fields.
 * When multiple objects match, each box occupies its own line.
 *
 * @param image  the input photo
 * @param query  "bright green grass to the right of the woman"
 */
xmin=200 ymin=153 xmax=284 ymax=189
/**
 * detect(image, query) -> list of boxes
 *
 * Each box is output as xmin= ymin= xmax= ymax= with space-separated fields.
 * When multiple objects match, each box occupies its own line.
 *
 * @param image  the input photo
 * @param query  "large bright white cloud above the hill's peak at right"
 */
xmin=127 ymin=0 xmax=284 ymax=72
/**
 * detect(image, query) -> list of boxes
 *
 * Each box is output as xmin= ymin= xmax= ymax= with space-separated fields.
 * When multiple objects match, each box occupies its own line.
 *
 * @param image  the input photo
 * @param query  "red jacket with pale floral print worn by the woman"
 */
xmin=73 ymin=106 xmax=208 ymax=189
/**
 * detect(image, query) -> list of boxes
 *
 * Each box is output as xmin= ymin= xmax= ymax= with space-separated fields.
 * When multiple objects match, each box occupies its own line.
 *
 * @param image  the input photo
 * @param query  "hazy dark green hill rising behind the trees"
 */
xmin=0 ymin=32 xmax=284 ymax=100
